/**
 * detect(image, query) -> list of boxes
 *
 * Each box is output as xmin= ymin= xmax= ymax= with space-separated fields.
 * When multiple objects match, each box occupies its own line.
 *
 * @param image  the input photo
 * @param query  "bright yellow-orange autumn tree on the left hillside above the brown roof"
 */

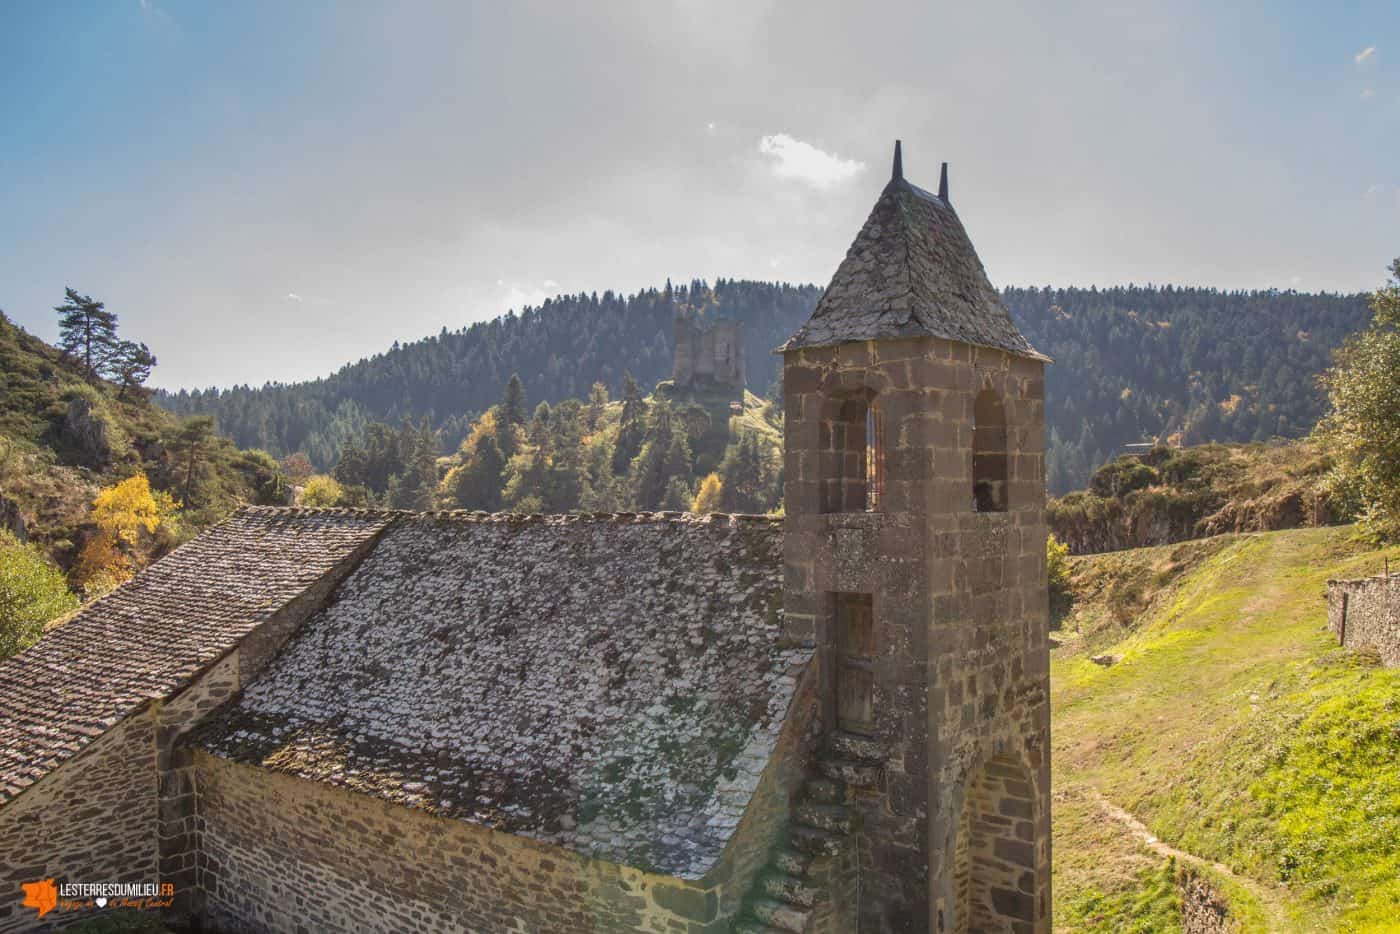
xmin=76 ymin=473 xmax=176 ymax=597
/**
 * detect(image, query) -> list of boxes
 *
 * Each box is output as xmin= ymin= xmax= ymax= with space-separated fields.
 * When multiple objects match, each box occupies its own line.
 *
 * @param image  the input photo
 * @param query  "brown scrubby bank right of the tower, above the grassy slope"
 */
xmin=1046 ymin=440 xmax=1332 ymax=555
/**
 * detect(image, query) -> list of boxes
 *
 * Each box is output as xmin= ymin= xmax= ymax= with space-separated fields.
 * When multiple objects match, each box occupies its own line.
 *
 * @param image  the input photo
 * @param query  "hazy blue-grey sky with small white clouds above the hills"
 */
xmin=0 ymin=0 xmax=1400 ymax=388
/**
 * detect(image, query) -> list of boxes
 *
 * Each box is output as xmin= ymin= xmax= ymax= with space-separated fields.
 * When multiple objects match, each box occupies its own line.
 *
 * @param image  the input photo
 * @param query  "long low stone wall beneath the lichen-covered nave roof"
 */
xmin=200 ymin=751 xmax=724 ymax=934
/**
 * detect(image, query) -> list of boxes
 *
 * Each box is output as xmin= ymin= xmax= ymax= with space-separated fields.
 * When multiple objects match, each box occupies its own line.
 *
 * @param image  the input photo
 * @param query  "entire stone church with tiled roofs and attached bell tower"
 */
xmin=0 ymin=142 xmax=1050 ymax=934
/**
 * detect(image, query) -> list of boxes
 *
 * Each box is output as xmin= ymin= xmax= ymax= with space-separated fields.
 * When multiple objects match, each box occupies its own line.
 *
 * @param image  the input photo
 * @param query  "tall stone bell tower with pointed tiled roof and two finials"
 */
xmin=781 ymin=143 xmax=1050 ymax=934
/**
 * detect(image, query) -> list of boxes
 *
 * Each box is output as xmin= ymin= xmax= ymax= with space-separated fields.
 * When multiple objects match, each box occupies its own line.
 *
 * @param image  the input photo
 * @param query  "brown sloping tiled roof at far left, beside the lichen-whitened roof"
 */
xmin=0 ymin=508 xmax=392 ymax=804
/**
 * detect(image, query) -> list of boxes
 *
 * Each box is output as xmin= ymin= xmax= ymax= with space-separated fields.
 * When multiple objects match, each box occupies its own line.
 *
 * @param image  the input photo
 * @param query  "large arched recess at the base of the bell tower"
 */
xmin=952 ymin=756 xmax=1040 ymax=934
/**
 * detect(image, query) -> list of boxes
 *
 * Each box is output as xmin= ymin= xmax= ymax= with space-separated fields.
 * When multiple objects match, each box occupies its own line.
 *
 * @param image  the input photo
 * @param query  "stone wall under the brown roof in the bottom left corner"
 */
xmin=0 ymin=710 xmax=158 ymax=934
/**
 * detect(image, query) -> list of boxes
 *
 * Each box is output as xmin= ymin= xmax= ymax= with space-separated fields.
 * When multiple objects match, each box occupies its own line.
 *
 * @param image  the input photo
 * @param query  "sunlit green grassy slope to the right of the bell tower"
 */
xmin=1051 ymin=528 xmax=1400 ymax=931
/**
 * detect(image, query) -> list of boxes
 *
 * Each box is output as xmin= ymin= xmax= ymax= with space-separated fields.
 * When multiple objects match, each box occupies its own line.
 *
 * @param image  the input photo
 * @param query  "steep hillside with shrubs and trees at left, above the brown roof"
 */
xmin=0 ymin=306 xmax=291 ymax=658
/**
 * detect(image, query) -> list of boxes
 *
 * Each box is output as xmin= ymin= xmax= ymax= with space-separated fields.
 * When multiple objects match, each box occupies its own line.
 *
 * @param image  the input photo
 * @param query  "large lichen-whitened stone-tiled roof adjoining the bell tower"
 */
xmin=192 ymin=514 xmax=811 ymax=878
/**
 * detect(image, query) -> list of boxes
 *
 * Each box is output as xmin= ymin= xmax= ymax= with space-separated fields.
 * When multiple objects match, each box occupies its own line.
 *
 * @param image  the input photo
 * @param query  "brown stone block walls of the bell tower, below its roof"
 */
xmin=784 ymin=339 xmax=1050 ymax=933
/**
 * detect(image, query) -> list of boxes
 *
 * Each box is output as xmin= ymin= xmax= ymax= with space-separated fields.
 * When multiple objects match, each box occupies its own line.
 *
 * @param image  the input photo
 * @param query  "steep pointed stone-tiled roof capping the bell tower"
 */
xmin=781 ymin=176 xmax=1046 ymax=360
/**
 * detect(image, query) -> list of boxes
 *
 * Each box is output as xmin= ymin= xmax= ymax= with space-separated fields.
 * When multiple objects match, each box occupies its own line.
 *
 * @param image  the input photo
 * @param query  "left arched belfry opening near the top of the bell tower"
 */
xmin=818 ymin=389 xmax=885 ymax=513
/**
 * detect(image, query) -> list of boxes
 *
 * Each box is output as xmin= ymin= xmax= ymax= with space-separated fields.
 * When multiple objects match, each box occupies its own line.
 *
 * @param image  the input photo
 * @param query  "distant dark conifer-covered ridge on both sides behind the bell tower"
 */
xmin=158 ymin=280 xmax=1368 ymax=493
